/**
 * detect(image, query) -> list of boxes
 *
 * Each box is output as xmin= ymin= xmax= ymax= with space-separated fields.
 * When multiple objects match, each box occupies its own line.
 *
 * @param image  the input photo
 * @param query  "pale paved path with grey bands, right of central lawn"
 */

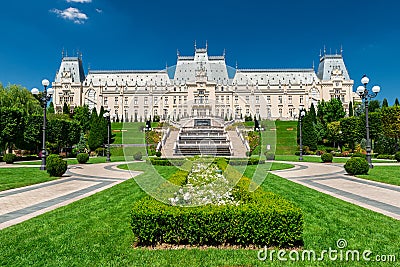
xmin=271 ymin=162 xmax=400 ymax=220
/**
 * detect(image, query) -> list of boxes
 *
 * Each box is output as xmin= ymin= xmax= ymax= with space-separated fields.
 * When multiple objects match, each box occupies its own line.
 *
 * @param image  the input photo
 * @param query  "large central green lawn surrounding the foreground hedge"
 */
xmin=0 ymin=163 xmax=400 ymax=266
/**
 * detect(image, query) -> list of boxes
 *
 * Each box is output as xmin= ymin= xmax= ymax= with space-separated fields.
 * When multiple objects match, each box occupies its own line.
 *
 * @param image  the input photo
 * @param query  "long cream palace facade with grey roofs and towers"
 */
xmin=52 ymin=46 xmax=359 ymax=121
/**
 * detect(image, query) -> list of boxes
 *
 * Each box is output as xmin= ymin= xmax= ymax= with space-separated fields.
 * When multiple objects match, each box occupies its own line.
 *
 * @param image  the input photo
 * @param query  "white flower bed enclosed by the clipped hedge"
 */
xmin=169 ymin=159 xmax=239 ymax=206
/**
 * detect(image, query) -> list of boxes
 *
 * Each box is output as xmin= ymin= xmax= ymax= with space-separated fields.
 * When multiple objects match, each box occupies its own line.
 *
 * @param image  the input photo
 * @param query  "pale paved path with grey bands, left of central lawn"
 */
xmin=0 ymin=162 xmax=140 ymax=229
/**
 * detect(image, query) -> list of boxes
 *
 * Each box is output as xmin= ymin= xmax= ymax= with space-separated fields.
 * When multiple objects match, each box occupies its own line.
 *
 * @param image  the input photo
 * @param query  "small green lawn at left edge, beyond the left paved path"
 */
xmin=0 ymin=168 xmax=58 ymax=191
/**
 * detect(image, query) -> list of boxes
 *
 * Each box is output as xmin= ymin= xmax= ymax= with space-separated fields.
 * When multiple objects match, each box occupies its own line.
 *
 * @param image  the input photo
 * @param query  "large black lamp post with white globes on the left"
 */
xmin=31 ymin=79 xmax=54 ymax=171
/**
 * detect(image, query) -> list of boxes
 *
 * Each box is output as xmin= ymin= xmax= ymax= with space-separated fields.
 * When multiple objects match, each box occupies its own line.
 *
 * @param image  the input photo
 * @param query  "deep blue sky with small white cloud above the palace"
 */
xmin=0 ymin=0 xmax=400 ymax=104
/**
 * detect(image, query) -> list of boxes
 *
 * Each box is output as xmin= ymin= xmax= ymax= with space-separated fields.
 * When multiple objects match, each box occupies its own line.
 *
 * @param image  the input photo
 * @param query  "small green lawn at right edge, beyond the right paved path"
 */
xmin=357 ymin=166 xmax=400 ymax=186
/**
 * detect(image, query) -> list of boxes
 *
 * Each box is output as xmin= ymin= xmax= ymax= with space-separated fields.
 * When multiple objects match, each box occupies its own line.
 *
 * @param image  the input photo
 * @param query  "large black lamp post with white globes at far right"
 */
xmin=357 ymin=74 xmax=381 ymax=169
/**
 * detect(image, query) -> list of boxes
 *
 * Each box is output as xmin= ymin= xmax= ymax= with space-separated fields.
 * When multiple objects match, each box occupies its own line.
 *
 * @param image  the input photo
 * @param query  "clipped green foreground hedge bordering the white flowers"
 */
xmin=131 ymin=159 xmax=303 ymax=247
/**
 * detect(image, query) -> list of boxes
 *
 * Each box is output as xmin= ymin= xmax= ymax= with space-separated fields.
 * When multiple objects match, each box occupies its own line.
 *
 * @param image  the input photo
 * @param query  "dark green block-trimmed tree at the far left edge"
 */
xmin=0 ymin=107 xmax=24 ymax=153
